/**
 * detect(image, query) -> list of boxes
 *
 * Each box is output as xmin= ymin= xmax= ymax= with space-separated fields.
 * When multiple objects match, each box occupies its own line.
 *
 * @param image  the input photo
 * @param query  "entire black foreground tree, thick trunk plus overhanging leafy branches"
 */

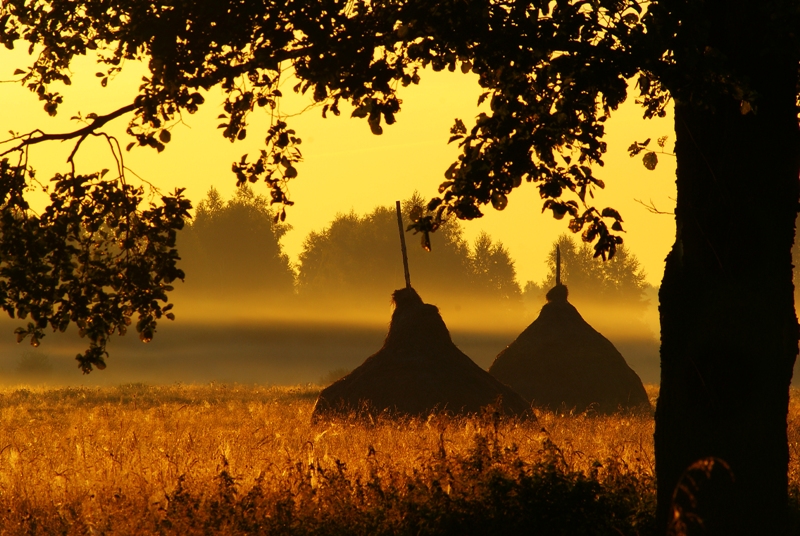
xmin=0 ymin=0 xmax=800 ymax=534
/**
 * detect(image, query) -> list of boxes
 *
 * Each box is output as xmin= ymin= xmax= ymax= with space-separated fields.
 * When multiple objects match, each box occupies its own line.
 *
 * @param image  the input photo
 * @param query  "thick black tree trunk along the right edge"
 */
xmin=655 ymin=1 xmax=800 ymax=535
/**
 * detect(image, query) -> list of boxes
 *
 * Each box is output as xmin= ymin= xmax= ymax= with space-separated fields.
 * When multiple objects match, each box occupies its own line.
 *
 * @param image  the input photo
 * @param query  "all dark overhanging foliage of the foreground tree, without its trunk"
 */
xmin=0 ymin=0 xmax=800 ymax=371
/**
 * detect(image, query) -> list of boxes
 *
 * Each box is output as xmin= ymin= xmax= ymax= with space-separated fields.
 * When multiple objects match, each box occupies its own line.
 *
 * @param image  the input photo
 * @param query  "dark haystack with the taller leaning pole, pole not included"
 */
xmin=313 ymin=287 xmax=530 ymax=420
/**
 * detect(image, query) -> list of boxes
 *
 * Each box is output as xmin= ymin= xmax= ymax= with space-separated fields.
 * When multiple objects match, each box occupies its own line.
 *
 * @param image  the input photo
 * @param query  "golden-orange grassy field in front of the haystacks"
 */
xmin=0 ymin=384 xmax=800 ymax=535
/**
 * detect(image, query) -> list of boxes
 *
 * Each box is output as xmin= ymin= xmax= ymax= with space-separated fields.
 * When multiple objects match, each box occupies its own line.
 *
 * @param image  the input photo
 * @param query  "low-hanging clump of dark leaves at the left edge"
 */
xmin=0 ymin=160 xmax=190 ymax=372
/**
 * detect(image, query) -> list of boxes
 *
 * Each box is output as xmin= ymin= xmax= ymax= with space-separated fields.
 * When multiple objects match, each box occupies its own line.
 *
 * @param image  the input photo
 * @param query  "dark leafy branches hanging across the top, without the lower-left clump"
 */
xmin=0 ymin=0 xmax=648 ymax=257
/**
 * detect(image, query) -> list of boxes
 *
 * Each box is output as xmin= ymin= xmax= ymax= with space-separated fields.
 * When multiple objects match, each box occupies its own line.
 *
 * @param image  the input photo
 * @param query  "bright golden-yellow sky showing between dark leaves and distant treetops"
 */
xmin=0 ymin=50 xmax=675 ymax=285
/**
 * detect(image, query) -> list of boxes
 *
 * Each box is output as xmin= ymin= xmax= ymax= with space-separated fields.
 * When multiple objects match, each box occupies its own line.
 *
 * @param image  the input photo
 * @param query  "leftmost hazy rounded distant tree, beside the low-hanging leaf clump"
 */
xmin=178 ymin=188 xmax=294 ymax=304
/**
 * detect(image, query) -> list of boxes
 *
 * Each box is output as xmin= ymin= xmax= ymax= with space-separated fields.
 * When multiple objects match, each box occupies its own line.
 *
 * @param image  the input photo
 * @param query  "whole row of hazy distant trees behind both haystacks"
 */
xmin=176 ymin=188 xmax=648 ymax=330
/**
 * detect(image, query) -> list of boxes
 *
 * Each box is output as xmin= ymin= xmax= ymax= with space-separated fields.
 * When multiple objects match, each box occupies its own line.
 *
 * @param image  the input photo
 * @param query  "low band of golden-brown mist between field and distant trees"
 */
xmin=0 ymin=283 xmax=659 ymax=385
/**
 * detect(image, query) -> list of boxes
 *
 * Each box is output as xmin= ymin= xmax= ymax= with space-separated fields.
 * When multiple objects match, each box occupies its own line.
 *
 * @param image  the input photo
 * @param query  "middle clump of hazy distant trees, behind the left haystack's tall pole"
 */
xmin=298 ymin=195 xmax=522 ymax=314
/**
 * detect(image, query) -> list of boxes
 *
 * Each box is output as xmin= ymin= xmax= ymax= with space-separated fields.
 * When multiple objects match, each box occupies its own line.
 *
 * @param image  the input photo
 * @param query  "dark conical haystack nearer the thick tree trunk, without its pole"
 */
xmin=489 ymin=284 xmax=650 ymax=413
